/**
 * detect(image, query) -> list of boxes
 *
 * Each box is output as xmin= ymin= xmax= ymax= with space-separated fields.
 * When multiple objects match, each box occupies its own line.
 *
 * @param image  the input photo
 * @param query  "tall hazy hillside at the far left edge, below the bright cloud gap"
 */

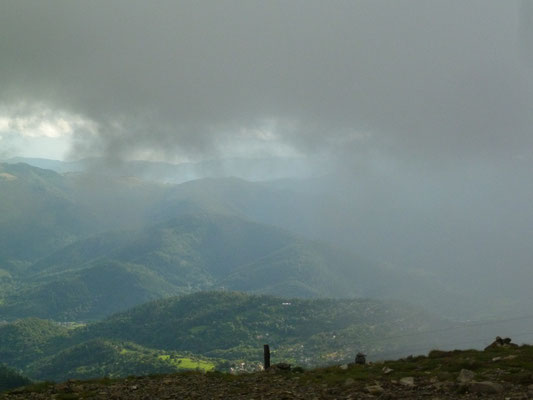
xmin=0 ymin=163 xmax=92 ymax=272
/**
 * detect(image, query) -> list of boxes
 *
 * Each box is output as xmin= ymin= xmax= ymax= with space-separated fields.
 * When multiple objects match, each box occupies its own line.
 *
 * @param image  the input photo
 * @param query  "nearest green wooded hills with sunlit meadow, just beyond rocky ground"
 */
xmin=0 ymin=292 xmax=448 ymax=380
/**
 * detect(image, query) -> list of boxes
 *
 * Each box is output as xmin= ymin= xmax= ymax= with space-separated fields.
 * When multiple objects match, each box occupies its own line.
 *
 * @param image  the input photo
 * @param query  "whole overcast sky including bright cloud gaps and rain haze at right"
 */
xmin=0 ymin=0 xmax=533 ymax=318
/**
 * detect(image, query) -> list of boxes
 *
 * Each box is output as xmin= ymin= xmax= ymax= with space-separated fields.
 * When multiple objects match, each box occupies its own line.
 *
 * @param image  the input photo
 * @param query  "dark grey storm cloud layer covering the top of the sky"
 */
xmin=0 ymin=0 xmax=533 ymax=158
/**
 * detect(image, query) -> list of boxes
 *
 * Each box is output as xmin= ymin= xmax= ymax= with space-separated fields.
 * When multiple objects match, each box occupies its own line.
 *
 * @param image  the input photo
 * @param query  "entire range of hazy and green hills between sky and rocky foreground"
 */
xmin=0 ymin=163 xmax=527 ymax=380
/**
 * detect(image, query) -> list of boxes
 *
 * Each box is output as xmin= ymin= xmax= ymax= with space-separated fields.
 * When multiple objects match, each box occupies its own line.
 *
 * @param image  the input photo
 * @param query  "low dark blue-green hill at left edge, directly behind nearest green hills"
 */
xmin=0 ymin=261 xmax=178 ymax=321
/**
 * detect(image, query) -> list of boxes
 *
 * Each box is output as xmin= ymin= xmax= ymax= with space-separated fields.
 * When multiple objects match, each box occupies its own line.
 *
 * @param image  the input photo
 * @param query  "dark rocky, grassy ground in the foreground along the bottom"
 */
xmin=4 ymin=346 xmax=533 ymax=400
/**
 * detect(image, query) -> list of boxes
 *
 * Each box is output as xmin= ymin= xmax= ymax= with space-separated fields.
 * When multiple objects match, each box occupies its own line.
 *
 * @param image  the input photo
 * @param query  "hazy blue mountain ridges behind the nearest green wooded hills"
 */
xmin=0 ymin=164 xmax=459 ymax=321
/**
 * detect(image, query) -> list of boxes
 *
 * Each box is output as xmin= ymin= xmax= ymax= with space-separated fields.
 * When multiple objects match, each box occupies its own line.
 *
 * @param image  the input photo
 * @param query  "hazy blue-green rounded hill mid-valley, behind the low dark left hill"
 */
xmin=32 ymin=213 xmax=295 ymax=286
